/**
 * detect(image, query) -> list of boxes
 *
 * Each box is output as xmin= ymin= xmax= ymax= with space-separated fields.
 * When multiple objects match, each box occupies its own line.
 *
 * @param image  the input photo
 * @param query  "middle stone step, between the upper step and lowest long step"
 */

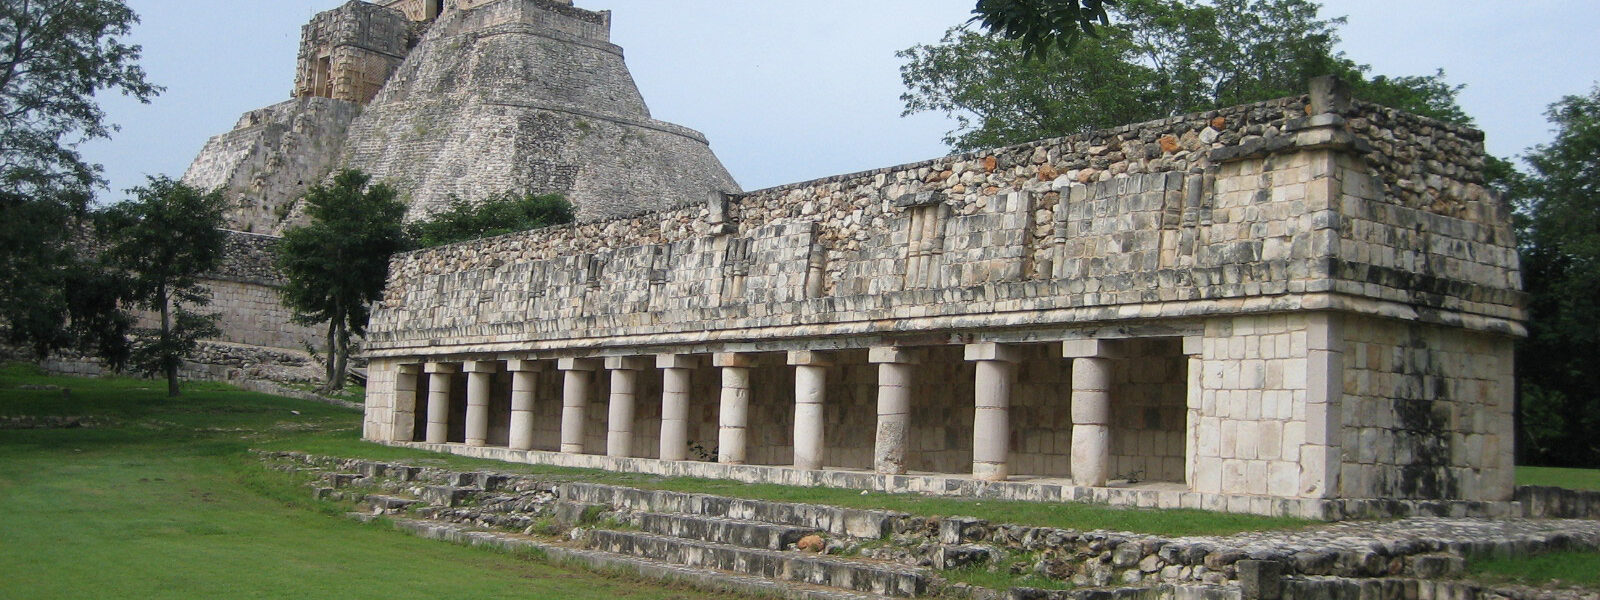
xmin=587 ymin=530 xmax=933 ymax=597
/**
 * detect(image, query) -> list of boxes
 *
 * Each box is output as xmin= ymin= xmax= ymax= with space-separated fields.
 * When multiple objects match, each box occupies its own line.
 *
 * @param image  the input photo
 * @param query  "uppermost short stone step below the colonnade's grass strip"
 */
xmin=557 ymin=483 xmax=907 ymax=539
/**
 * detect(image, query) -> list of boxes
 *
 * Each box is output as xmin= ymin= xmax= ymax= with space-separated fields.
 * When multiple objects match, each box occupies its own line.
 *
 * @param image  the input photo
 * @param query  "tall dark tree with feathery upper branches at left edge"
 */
xmin=0 ymin=0 xmax=160 ymax=355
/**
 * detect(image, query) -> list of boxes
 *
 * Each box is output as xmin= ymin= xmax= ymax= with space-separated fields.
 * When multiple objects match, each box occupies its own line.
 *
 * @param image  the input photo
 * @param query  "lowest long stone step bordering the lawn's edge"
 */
xmin=379 ymin=515 xmax=886 ymax=600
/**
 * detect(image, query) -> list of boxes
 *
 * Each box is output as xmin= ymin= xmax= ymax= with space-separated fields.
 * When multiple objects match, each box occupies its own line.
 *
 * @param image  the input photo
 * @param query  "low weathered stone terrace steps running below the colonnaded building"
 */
xmin=262 ymin=453 xmax=1600 ymax=600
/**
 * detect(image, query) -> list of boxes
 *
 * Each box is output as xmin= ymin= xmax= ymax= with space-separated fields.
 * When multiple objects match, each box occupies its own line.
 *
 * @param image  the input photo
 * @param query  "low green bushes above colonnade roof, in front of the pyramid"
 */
xmin=406 ymin=192 xmax=574 ymax=248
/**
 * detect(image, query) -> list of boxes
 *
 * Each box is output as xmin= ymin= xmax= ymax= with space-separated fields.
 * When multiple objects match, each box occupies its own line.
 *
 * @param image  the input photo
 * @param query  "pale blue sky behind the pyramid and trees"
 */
xmin=82 ymin=0 xmax=1600 ymax=202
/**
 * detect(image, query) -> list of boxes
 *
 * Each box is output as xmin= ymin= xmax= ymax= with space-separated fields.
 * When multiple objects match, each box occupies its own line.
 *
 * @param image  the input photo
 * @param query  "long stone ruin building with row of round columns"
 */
xmin=363 ymin=80 xmax=1525 ymax=518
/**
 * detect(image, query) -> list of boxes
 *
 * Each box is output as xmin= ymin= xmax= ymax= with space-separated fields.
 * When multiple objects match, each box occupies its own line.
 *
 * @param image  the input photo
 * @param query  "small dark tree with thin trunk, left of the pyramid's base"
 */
xmin=104 ymin=178 xmax=226 ymax=397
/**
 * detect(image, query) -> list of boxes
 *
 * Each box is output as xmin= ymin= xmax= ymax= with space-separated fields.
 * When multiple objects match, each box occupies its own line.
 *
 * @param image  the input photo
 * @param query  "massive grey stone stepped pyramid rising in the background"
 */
xmin=184 ymin=0 xmax=739 ymax=234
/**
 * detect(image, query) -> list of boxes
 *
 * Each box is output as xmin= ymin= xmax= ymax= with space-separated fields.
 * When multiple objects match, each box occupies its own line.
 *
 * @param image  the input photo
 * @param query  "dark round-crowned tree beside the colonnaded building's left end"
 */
xmin=278 ymin=170 xmax=405 ymax=390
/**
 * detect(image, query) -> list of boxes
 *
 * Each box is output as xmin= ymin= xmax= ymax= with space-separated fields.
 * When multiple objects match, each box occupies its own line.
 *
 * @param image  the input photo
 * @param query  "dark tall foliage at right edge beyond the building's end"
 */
xmin=1502 ymin=86 xmax=1600 ymax=466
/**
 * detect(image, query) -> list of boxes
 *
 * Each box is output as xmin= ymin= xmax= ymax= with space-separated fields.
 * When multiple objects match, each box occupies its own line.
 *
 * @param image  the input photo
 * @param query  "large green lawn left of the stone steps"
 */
xmin=0 ymin=366 xmax=745 ymax=600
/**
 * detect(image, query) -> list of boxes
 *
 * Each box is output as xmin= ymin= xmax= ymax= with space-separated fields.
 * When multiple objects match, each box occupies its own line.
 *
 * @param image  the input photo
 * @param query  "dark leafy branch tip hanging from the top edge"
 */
xmin=973 ymin=0 xmax=1117 ymax=59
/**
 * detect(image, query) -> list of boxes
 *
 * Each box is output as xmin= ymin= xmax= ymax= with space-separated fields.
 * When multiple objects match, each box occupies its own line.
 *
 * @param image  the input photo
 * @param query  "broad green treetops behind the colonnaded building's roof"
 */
xmin=899 ymin=0 xmax=1467 ymax=150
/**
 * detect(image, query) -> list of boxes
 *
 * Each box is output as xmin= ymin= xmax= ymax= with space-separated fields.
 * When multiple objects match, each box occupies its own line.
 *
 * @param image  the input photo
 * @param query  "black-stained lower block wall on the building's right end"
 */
xmin=1339 ymin=315 xmax=1514 ymax=501
